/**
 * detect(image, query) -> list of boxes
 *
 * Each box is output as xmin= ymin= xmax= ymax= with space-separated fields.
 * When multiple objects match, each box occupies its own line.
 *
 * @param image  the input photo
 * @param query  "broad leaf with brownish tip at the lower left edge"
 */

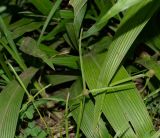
xmin=0 ymin=68 xmax=37 ymax=138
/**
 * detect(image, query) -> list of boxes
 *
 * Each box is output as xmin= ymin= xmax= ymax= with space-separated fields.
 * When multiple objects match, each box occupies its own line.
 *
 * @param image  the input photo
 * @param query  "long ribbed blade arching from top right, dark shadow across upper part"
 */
xmin=94 ymin=1 xmax=159 ymax=129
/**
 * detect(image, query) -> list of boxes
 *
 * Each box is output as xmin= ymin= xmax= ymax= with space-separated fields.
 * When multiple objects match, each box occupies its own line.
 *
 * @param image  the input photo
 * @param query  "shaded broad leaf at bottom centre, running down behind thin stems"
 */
xmin=69 ymin=79 xmax=111 ymax=138
